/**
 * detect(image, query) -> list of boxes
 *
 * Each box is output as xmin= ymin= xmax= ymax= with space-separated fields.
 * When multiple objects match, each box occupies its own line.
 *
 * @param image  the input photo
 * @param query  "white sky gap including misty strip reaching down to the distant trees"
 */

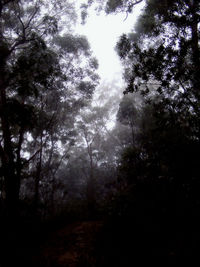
xmin=74 ymin=3 xmax=144 ymax=129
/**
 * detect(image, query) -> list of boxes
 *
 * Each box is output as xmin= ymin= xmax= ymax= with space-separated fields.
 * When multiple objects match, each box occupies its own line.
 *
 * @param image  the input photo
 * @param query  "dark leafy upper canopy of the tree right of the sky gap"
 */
xmin=117 ymin=1 xmax=199 ymax=112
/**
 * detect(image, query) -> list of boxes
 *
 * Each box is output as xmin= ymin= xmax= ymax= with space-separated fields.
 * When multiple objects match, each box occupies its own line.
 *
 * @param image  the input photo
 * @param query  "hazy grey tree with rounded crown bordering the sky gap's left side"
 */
xmin=22 ymin=34 xmax=98 ymax=214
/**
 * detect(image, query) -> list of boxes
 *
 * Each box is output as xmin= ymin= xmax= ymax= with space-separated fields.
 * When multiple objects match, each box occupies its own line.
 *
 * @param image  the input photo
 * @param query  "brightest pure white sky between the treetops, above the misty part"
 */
xmin=77 ymin=4 xmax=143 ymax=83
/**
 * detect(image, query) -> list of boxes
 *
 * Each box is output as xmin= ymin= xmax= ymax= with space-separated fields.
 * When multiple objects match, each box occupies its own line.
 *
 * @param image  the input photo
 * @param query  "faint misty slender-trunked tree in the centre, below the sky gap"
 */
xmin=77 ymin=106 xmax=110 ymax=216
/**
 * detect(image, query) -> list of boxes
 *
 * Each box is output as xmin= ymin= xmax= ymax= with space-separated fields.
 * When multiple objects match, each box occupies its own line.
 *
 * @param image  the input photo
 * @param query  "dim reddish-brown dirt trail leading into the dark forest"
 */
xmin=40 ymin=221 xmax=103 ymax=267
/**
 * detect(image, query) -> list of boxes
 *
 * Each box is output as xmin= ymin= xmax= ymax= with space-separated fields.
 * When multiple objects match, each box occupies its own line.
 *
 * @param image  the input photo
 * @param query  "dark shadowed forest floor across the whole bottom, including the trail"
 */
xmin=0 ymin=217 xmax=200 ymax=267
